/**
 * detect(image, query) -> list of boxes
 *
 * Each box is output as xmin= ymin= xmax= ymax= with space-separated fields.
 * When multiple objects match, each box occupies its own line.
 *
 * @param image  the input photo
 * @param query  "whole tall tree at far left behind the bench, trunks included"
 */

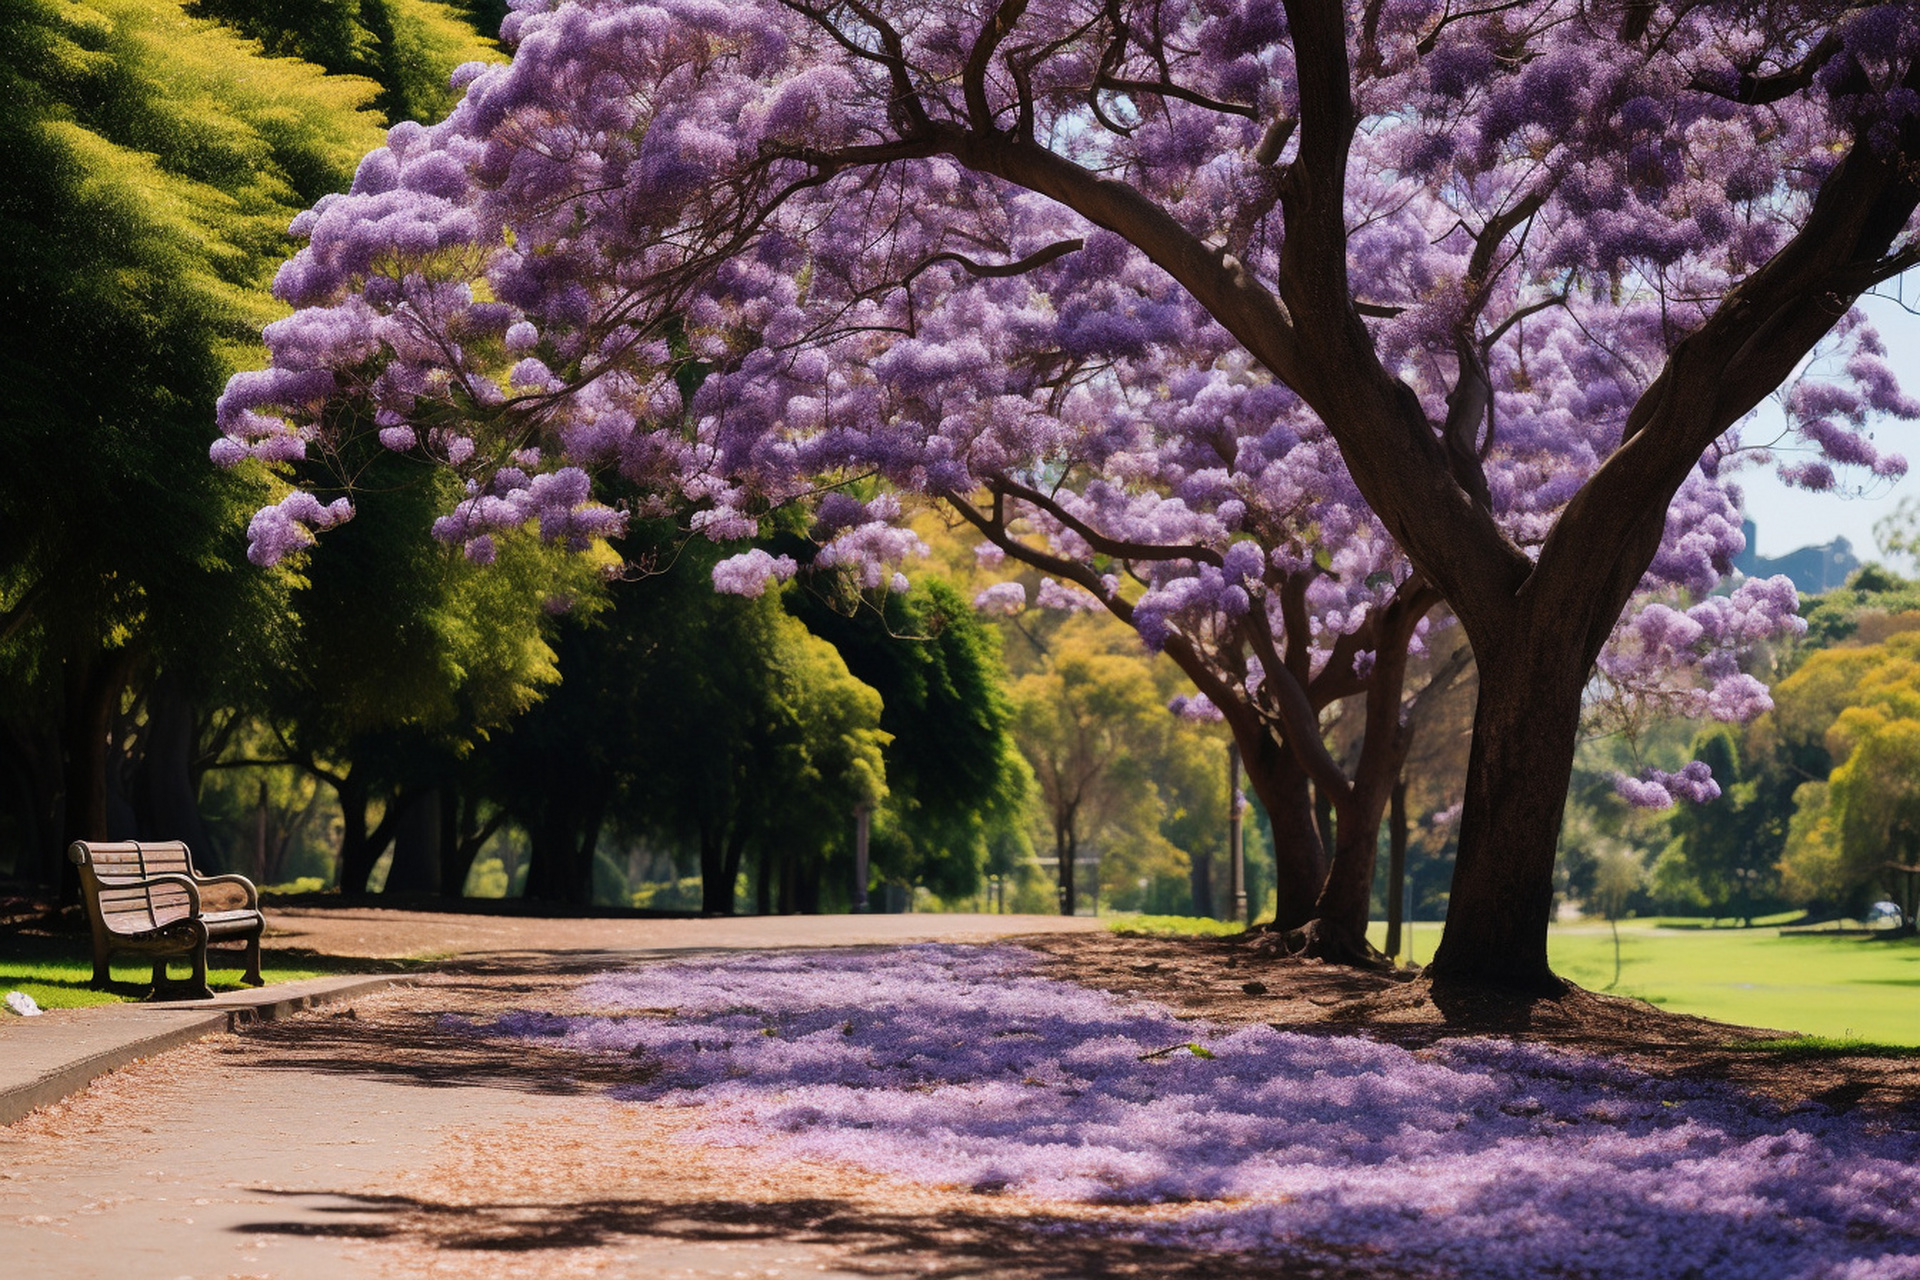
xmin=0 ymin=0 xmax=391 ymax=879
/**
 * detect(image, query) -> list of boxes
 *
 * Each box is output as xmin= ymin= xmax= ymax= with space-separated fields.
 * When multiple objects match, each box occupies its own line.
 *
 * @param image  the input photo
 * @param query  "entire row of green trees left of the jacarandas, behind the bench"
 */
xmin=0 ymin=0 xmax=1225 ymax=910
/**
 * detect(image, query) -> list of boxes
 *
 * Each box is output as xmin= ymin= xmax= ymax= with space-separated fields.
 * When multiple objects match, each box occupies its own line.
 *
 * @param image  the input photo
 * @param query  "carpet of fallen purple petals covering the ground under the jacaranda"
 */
xmin=453 ymin=946 xmax=1920 ymax=1280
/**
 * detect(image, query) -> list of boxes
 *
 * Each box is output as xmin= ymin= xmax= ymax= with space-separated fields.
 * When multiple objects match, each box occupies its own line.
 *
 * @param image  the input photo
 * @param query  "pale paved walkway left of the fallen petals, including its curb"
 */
xmin=0 ymin=912 xmax=1121 ymax=1280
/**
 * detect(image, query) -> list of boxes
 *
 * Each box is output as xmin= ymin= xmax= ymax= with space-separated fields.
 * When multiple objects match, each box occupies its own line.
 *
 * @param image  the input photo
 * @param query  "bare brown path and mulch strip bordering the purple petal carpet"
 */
xmin=0 ymin=908 xmax=1920 ymax=1280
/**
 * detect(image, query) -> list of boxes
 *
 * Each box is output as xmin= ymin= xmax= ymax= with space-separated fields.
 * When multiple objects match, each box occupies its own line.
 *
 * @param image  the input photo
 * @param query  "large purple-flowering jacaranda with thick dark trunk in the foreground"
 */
xmin=215 ymin=0 xmax=1920 ymax=988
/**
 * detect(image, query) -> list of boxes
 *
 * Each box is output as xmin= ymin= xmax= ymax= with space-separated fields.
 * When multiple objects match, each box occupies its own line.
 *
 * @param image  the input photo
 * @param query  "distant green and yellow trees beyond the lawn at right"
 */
xmin=1561 ymin=545 xmax=1920 ymax=923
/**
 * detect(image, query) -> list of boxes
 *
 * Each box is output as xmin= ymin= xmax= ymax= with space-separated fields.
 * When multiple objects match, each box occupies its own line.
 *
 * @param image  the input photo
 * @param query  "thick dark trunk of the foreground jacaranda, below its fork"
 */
xmin=1430 ymin=652 xmax=1588 ymax=994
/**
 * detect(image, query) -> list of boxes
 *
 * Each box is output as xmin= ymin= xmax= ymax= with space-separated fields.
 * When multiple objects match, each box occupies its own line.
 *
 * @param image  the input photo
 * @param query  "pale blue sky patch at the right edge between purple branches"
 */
xmin=1738 ymin=289 xmax=1920 ymax=572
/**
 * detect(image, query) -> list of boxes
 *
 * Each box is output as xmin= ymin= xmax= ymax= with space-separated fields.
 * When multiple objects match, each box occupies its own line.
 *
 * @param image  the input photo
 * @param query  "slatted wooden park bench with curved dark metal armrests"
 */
xmin=67 ymin=841 xmax=267 ymax=1000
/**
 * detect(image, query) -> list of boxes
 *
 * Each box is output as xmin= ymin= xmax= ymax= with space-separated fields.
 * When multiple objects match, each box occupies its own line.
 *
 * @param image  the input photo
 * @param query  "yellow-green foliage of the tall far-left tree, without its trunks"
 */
xmin=0 ymin=0 xmax=389 ymax=652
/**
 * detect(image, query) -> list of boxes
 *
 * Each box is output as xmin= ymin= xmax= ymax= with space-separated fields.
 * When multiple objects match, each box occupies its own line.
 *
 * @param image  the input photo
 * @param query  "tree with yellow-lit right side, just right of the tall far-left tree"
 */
xmin=265 ymin=466 xmax=605 ymax=892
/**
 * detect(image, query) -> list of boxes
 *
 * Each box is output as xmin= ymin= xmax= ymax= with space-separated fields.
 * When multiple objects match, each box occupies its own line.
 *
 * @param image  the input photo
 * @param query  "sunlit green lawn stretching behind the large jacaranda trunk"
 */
xmin=1373 ymin=919 xmax=1920 ymax=1046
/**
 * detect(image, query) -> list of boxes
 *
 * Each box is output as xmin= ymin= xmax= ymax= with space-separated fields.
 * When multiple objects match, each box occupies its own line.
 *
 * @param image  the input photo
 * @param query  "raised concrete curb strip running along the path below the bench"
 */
xmin=0 ymin=973 xmax=396 ymax=1125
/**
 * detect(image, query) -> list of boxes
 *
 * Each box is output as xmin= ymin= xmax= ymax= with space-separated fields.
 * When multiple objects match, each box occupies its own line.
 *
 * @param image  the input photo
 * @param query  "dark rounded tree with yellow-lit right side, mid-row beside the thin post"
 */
xmin=478 ymin=528 xmax=885 ymax=913
